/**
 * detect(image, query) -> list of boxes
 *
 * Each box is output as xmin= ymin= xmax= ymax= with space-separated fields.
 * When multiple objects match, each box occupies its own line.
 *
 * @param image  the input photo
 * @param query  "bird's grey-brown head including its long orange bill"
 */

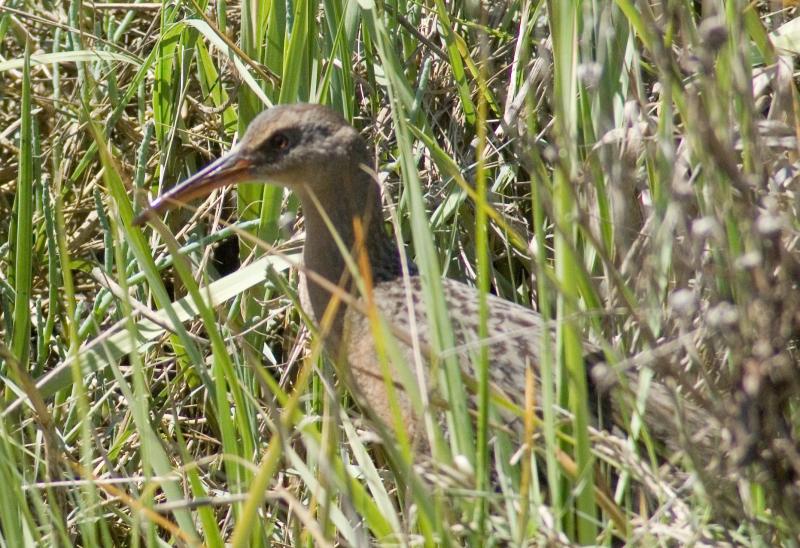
xmin=134 ymin=104 xmax=366 ymax=224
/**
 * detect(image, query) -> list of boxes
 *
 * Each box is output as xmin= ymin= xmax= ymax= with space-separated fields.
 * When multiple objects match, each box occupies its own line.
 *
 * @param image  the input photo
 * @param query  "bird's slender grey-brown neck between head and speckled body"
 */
xmin=299 ymin=166 xmax=410 ymax=330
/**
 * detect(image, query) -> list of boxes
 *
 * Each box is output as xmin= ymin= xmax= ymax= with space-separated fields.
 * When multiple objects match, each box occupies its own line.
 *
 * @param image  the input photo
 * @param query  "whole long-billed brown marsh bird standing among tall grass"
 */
xmin=135 ymin=104 xmax=703 ymax=460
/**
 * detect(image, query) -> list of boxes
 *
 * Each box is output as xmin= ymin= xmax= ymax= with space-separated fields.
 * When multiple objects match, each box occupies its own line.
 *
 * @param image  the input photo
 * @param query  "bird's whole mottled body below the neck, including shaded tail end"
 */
xmin=344 ymin=276 xmax=713 ymax=460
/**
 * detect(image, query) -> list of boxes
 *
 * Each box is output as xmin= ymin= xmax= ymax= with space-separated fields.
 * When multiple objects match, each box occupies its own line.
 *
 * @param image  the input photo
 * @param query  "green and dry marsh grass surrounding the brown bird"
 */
xmin=0 ymin=0 xmax=800 ymax=546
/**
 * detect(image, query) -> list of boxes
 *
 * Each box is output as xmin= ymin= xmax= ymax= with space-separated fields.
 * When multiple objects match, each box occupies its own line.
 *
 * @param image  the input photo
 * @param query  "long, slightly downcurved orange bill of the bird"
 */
xmin=133 ymin=150 xmax=253 ymax=226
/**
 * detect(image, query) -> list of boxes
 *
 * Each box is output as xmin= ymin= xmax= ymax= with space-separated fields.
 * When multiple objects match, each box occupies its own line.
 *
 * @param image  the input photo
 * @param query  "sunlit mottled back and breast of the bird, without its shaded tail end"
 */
xmin=345 ymin=276 xmax=596 ymax=440
